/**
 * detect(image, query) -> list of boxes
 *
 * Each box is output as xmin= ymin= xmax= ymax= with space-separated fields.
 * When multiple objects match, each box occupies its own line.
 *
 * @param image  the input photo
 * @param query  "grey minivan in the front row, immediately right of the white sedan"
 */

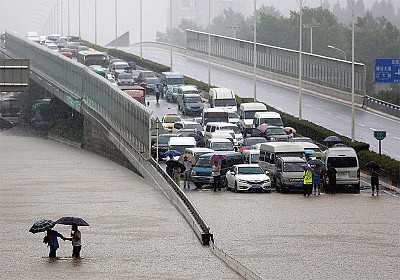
xmin=274 ymin=157 xmax=307 ymax=192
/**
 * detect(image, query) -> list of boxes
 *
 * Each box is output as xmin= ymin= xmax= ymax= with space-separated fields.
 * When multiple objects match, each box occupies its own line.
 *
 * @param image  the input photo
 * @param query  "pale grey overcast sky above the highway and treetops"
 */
xmin=0 ymin=0 xmax=400 ymax=44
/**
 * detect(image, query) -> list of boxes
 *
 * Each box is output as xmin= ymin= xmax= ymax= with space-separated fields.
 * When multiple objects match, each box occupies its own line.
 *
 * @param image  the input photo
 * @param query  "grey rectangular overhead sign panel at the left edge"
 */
xmin=0 ymin=59 xmax=30 ymax=92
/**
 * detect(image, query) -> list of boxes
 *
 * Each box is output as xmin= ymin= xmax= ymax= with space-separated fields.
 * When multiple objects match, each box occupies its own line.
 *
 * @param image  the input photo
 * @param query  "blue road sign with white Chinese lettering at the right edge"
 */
xmin=375 ymin=58 xmax=400 ymax=83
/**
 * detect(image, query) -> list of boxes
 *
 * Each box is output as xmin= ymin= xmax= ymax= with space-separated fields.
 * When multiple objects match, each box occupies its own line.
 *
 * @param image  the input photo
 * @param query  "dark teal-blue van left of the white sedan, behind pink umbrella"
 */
xmin=190 ymin=152 xmax=244 ymax=188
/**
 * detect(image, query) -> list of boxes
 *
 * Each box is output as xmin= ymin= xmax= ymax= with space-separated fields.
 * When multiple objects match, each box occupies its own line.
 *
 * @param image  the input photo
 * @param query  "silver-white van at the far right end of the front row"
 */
xmin=322 ymin=144 xmax=360 ymax=193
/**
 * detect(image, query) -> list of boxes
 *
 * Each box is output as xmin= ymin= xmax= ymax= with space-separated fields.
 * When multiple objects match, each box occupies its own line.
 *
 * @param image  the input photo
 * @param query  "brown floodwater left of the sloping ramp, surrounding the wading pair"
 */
xmin=0 ymin=127 xmax=241 ymax=279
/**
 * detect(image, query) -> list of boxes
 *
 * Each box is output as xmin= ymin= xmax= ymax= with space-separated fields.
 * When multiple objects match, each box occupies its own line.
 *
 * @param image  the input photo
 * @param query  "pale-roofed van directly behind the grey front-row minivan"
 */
xmin=258 ymin=142 xmax=305 ymax=186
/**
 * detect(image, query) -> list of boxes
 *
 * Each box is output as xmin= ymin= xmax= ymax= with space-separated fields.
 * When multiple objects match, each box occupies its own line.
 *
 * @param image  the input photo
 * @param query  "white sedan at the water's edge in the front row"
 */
xmin=224 ymin=164 xmax=271 ymax=192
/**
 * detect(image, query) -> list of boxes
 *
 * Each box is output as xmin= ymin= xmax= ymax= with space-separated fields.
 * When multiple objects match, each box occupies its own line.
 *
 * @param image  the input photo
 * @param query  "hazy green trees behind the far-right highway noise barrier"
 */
xmin=156 ymin=0 xmax=400 ymax=105
